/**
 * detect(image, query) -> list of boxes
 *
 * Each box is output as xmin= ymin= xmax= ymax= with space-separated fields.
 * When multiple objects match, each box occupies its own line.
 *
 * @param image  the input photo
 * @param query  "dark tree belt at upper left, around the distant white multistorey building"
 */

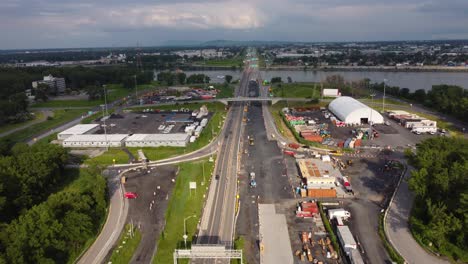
xmin=0 ymin=66 xmax=154 ymax=125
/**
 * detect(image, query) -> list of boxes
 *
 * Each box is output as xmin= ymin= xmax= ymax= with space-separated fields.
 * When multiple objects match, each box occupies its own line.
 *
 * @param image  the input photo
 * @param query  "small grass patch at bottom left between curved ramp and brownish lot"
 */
xmin=110 ymin=224 xmax=141 ymax=264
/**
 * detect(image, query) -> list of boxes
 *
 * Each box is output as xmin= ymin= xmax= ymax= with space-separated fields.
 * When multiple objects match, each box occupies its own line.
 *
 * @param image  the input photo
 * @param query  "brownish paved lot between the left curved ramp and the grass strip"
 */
xmin=111 ymin=166 xmax=177 ymax=263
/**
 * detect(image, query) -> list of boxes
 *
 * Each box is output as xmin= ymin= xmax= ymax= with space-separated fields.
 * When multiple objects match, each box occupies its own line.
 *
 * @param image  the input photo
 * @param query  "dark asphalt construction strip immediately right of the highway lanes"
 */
xmin=236 ymin=103 xmax=293 ymax=263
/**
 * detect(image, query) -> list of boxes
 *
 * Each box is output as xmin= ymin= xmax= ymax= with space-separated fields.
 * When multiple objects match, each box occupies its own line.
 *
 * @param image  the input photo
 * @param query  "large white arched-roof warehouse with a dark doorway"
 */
xmin=328 ymin=96 xmax=384 ymax=124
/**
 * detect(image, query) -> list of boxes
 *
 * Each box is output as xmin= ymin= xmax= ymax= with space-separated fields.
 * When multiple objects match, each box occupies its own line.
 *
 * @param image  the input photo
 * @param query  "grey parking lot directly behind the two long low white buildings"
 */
xmin=92 ymin=111 xmax=211 ymax=134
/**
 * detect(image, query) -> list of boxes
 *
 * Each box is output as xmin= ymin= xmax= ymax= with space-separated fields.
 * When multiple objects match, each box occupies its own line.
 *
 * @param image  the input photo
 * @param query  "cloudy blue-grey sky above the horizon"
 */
xmin=0 ymin=0 xmax=468 ymax=49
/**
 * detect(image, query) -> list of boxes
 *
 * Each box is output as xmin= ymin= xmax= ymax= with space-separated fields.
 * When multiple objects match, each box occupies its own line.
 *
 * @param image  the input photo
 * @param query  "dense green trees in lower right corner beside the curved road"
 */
xmin=409 ymin=137 xmax=468 ymax=262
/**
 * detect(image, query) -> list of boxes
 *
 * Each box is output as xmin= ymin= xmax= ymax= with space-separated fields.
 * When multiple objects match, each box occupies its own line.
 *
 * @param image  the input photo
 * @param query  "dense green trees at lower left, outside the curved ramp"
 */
xmin=0 ymin=143 xmax=107 ymax=263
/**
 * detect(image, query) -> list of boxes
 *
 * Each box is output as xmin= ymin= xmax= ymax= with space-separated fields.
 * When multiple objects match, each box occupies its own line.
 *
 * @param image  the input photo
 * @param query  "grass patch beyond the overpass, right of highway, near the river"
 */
xmin=272 ymin=83 xmax=320 ymax=99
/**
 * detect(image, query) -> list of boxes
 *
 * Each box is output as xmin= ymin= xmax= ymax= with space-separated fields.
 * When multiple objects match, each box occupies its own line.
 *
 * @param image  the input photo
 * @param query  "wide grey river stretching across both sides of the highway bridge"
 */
xmin=167 ymin=70 xmax=468 ymax=91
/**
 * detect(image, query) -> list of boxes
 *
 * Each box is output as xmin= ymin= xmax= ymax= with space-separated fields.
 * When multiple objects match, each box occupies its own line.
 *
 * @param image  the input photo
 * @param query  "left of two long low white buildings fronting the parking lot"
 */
xmin=62 ymin=134 xmax=128 ymax=148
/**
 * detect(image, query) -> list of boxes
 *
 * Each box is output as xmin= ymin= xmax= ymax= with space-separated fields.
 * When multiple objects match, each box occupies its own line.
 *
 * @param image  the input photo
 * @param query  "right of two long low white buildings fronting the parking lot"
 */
xmin=125 ymin=133 xmax=190 ymax=147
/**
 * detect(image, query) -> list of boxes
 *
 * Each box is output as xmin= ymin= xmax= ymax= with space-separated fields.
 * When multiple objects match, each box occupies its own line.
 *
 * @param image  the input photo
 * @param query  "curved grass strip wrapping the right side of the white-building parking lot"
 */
xmin=124 ymin=103 xmax=226 ymax=161
